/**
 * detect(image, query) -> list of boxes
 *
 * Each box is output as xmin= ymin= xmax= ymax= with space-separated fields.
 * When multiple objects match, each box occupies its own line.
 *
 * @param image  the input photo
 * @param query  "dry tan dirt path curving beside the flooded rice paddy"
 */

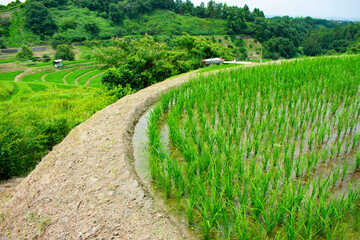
xmin=0 ymin=70 xmax=197 ymax=240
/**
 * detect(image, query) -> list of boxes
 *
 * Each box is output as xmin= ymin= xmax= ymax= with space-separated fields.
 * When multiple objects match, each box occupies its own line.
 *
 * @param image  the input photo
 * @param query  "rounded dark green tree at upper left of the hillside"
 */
xmin=25 ymin=2 xmax=57 ymax=35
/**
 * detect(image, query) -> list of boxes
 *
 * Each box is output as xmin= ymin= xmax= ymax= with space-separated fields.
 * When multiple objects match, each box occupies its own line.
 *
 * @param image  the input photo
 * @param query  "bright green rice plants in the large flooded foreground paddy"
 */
xmin=148 ymin=56 xmax=360 ymax=239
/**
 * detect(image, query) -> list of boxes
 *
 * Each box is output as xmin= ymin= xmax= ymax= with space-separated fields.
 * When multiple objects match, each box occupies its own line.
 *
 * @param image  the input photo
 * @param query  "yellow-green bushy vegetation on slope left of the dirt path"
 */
xmin=0 ymin=85 xmax=132 ymax=179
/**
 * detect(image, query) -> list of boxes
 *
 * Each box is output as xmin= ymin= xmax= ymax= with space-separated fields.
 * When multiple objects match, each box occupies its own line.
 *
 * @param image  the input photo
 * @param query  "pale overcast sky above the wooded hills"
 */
xmin=0 ymin=0 xmax=360 ymax=21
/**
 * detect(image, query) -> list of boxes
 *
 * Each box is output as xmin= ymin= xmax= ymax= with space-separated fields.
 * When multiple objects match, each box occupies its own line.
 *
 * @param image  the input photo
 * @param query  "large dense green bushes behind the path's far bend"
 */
xmin=97 ymin=34 xmax=234 ymax=89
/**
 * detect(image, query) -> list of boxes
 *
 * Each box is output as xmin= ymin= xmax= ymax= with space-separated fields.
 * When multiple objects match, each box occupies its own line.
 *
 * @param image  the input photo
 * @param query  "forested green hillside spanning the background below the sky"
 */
xmin=0 ymin=0 xmax=360 ymax=59
